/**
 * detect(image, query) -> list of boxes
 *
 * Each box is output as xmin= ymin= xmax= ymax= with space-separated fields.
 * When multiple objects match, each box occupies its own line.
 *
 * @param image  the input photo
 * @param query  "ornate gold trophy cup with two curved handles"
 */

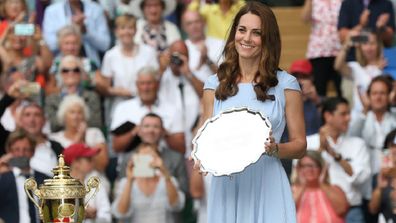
xmin=25 ymin=155 xmax=100 ymax=223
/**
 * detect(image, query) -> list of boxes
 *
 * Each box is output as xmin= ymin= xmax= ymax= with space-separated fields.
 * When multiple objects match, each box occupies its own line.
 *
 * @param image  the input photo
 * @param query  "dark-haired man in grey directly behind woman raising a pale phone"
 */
xmin=119 ymin=113 xmax=188 ymax=193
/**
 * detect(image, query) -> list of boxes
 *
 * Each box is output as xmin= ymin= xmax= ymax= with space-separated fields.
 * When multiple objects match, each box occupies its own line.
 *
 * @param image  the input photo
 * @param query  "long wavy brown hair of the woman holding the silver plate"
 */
xmin=215 ymin=1 xmax=281 ymax=101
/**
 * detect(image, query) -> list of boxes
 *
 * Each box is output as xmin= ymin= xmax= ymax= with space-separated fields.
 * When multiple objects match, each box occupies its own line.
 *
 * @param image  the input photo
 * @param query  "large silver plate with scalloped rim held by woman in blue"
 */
xmin=191 ymin=107 xmax=271 ymax=176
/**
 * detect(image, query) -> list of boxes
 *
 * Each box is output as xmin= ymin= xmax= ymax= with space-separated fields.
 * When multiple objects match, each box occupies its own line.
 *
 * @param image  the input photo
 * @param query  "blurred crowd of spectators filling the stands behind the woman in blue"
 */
xmin=0 ymin=0 xmax=396 ymax=223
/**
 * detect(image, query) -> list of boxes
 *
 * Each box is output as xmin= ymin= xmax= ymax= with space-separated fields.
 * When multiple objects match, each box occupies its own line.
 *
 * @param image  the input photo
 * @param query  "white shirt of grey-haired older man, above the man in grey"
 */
xmin=110 ymin=97 xmax=183 ymax=134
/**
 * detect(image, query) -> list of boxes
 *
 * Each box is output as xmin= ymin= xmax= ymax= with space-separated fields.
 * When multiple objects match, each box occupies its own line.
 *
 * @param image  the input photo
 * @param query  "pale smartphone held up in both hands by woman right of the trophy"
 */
xmin=133 ymin=154 xmax=155 ymax=177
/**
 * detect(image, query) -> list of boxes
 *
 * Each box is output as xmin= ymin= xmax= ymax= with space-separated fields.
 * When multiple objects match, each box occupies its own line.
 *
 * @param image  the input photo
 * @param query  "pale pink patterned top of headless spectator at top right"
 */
xmin=306 ymin=0 xmax=342 ymax=59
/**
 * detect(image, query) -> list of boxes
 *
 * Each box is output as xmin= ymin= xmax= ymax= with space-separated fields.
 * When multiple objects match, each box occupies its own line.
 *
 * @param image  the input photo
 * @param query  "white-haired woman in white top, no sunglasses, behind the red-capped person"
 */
xmin=50 ymin=95 xmax=108 ymax=172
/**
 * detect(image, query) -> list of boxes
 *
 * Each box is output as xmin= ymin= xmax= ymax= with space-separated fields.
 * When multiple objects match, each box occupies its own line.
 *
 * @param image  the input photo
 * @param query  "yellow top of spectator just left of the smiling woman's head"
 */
xmin=188 ymin=0 xmax=245 ymax=40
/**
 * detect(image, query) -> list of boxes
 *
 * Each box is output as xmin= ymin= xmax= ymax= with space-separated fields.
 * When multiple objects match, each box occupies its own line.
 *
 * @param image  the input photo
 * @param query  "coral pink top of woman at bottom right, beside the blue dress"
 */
xmin=297 ymin=189 xmax=344 ymax=223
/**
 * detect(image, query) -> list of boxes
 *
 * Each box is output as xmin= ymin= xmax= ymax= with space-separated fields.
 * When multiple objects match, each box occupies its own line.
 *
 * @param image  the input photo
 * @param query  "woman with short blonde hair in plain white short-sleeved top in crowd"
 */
xmin=98 ymin=15 xmax=158 ymax=106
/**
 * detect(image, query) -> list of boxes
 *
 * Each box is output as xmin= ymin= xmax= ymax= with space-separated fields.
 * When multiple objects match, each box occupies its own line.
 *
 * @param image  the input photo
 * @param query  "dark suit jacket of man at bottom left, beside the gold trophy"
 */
xmin=0 ymin=171 xmax=49 ymax=223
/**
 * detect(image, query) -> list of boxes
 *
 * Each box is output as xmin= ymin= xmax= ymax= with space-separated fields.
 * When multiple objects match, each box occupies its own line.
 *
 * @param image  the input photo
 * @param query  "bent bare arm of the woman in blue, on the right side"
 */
xmin=279 ymin=90 xmax=307 ymax=159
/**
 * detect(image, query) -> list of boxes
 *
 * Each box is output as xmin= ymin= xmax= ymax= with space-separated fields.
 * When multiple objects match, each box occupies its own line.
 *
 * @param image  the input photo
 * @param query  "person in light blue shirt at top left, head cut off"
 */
xmin=43 ymin=0 xmax=110 ymax=65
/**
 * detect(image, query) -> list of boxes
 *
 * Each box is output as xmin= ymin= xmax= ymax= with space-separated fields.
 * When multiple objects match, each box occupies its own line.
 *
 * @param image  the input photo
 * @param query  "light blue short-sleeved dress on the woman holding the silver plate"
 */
xmin=204 ymin=71 xmax=300 ymax=223
